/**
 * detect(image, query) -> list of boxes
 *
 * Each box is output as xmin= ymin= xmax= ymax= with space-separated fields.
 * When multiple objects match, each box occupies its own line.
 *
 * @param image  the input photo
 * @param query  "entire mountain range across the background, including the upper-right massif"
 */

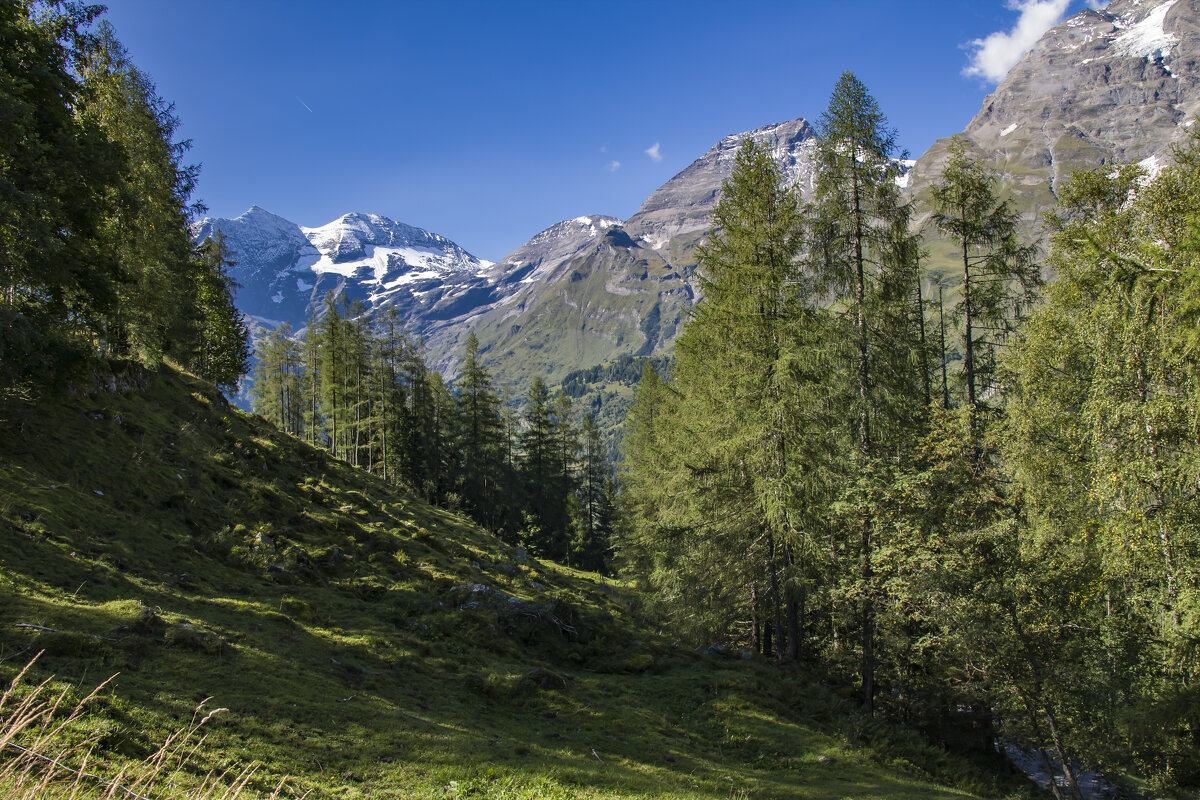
xmin=211 ymin=0 xmax=1200 ymax=407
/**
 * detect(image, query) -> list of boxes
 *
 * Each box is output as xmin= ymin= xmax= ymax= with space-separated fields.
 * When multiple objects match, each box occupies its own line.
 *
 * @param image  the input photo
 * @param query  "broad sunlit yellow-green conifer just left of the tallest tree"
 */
xmin=619 ymin=139 xmax=830 ymax=660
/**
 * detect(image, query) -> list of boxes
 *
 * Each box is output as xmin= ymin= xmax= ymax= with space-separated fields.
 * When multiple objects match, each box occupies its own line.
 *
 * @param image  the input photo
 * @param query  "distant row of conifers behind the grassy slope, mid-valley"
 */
xmin=253 ymin=309 xmax=617 ymax=572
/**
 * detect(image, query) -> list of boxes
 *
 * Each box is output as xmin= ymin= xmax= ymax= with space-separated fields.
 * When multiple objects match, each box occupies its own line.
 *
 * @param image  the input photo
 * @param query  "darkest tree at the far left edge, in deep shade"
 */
xmin=0 ymin=0 xmax=122 ymax=386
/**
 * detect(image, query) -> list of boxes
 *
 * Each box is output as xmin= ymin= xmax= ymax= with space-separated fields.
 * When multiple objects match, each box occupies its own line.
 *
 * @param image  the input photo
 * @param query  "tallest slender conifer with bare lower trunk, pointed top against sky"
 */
xmin=809 ymin=72 xmax=922 ymax=711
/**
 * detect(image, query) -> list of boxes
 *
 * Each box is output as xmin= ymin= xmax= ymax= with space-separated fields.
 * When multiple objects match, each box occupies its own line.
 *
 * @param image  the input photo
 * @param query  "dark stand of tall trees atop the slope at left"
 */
xmin=0 ymin=1 xmax=250 ymax=387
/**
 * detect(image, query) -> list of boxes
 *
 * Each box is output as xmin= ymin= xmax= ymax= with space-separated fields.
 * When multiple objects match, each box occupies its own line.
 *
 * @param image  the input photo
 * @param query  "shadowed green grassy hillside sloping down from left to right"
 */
xmin=0 ymin=371 xmax=1012 ymax=798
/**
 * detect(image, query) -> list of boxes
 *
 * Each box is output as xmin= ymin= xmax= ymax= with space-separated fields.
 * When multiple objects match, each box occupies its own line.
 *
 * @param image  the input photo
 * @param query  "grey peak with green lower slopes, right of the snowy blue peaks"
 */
xmin=446 ymin=120 xmax=816 ymax=386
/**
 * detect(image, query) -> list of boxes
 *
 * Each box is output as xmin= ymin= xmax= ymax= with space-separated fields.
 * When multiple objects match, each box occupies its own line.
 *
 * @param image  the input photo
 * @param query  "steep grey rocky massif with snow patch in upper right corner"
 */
xmin=912 ymin=0 xmax=1200 ymax=241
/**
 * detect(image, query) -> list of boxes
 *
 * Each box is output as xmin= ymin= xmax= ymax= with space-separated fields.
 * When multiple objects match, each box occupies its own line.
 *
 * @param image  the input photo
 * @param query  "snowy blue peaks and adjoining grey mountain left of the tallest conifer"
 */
xmin=201 ymin=120 xmax=815 ymax=390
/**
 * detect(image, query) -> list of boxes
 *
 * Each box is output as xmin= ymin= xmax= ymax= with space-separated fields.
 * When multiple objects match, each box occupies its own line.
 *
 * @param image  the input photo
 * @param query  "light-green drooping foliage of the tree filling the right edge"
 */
xmin=1002 ymin=133 xmax=1200 ymax=787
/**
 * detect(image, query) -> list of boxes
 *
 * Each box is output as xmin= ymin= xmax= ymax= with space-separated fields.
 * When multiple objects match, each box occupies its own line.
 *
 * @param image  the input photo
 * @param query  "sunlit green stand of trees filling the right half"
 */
xmin=618 ymin=74 xmax=1200 ymax=796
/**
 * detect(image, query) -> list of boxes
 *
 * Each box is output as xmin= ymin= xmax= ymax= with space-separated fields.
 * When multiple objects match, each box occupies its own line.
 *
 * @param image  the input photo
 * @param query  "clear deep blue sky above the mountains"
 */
xmin=100 ymin=0 xmax=1094 ymax=260
